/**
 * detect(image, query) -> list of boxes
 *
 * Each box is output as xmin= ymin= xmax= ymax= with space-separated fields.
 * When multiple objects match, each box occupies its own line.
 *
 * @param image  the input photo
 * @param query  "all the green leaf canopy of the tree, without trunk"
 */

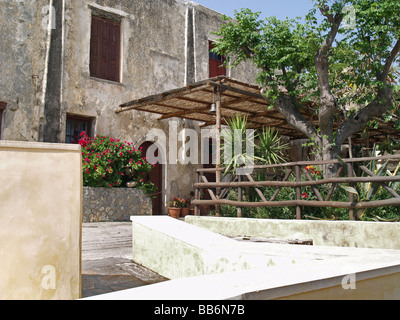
xmin=214 ymin=0 xmax=400 ymax=154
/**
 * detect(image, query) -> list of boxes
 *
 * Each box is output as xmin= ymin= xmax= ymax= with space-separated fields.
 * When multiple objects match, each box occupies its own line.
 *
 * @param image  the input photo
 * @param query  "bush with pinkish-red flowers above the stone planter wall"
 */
xmin=79 ymin=132 xmax=157 ymax=194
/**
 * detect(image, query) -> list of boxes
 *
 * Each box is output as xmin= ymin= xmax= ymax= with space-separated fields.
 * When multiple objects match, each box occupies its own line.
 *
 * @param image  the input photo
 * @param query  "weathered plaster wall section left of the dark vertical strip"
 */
xmin=0 ymin=0 xmax=48 ymax=141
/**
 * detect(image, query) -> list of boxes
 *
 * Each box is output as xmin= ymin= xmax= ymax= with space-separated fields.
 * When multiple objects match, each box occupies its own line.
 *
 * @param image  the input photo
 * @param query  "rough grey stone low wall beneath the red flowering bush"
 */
xmin=83 ymin=187 xmax=152 ymax=223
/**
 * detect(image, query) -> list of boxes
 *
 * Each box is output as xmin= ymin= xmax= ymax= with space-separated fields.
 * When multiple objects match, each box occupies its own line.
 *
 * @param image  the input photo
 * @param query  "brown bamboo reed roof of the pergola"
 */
xmin=116 ymin=76 xmax=400 ymax=145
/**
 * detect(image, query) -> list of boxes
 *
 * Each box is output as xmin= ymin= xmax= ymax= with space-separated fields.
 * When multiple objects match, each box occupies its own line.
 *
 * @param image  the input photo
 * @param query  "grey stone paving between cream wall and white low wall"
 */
xmin=82 ymin=222 xmax=167 ymax=298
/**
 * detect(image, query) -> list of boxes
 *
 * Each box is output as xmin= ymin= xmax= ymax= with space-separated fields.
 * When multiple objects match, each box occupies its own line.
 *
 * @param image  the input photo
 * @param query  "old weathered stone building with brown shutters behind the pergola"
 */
xmin=0 ymin=0 xmax=256 ymax=213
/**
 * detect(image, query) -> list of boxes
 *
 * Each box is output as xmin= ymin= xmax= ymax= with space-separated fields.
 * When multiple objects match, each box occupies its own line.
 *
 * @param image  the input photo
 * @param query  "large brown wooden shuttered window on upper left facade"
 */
xmin=90 ymin=16 xmax=121 ymax=82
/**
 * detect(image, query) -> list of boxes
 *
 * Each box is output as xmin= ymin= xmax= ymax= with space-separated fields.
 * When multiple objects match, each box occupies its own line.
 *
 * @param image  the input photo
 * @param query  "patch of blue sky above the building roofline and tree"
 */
xmin=194 ymin=0 xmax=313 ymax=20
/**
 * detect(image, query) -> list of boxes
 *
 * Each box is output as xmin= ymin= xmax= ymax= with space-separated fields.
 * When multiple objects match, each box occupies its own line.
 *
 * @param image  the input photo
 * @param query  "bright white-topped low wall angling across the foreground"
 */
xmin=83 ymin=217 xmax=400 ymax=300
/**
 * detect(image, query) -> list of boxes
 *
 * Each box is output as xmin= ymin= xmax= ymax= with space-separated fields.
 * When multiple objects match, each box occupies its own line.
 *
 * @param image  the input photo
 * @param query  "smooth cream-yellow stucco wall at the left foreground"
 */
xmin=0 ymin=141 xmax=82 ymax=300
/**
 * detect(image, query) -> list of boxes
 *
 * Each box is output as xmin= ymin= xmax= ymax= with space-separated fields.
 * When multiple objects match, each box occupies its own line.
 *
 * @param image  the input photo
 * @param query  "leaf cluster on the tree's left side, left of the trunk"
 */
xmin=214 ymin=9 xmax=322 ymax=101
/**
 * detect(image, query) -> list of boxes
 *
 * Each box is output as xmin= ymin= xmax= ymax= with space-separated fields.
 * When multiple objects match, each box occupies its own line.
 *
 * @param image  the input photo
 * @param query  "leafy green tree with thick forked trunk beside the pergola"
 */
xmin=215 ymin=0 xmax=400 ymax=175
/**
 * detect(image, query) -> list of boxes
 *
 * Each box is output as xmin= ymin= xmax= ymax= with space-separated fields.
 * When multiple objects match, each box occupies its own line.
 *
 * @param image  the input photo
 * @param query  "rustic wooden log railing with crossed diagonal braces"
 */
xmin=192 ymin=155 xmax=400 ymax=220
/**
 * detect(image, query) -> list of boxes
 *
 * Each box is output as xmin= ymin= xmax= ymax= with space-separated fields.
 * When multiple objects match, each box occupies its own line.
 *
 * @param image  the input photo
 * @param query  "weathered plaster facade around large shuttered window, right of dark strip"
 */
xmin=61 ymin=0 xmax=255 ymax=210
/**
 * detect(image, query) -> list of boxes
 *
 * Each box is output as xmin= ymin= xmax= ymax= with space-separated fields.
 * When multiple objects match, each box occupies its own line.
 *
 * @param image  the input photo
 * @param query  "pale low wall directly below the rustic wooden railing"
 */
xmin=185 ymin=216 xmax=400 ymax=250
